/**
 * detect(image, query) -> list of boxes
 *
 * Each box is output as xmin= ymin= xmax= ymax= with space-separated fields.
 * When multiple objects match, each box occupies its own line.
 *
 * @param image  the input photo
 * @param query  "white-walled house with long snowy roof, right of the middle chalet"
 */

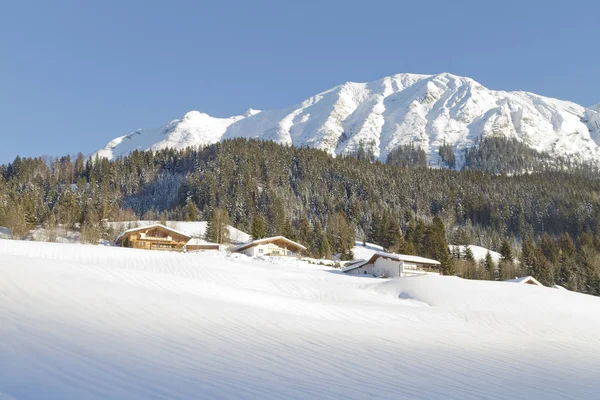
xmin=343 ymin=252 xmax=440 ymax=278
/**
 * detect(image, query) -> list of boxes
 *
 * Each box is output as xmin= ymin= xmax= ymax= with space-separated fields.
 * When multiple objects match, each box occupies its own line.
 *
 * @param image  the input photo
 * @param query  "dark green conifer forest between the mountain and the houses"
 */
xmin=0 ymin=139 xmax=600 ymax=294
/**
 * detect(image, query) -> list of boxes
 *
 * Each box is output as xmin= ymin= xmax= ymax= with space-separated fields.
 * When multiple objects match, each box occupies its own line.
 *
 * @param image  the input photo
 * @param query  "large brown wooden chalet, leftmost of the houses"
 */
xmin=116 ymin=224 xmax=192 ymax=251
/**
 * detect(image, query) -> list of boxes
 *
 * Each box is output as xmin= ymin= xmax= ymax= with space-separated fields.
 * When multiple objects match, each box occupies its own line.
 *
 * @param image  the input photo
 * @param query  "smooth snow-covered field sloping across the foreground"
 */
xmin=0 ymin=241 xmax=600 ymax=400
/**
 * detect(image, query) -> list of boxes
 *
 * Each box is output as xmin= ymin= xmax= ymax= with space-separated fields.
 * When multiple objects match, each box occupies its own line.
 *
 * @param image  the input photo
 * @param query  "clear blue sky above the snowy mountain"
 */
xmin=0 ymin=0 xmax=600 ymax=163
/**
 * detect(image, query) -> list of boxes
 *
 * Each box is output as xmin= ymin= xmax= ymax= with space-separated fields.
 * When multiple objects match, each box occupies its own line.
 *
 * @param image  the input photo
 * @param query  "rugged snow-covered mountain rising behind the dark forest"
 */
xmin=97 ymin=73 xmax=600 ymax=166
